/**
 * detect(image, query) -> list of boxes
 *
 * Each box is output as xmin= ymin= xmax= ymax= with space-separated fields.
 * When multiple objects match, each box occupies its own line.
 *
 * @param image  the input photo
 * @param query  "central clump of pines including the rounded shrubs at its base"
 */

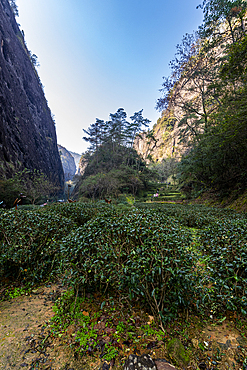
xmin=75 ymin=108 xmax=150 ymax=198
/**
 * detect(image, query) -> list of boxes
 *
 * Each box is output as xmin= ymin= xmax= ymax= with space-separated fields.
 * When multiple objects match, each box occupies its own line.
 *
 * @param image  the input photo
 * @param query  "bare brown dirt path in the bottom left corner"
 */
xmin=0 ymin=285 xmax=88 ymax=370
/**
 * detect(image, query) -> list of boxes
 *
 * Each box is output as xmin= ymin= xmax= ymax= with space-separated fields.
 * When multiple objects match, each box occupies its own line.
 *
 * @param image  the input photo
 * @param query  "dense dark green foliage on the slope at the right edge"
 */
xmin=180 ymin=36 xmax=247 ymax=191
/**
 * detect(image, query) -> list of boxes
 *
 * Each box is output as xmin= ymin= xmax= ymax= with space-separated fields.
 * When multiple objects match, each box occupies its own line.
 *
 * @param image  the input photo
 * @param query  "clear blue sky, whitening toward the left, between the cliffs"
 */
xmin=16 ymin=0 xmax=203 ymax=154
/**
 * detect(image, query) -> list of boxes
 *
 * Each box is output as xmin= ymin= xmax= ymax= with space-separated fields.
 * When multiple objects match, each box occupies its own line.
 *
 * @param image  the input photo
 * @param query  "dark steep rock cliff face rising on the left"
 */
xmin=0 ymin=0 xmax=64 ymax=185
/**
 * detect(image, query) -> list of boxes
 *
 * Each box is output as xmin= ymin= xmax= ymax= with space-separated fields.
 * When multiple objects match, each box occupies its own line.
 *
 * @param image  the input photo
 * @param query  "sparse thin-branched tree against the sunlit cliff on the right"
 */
xmin=157 ymin=34 xmax=220 ymax=144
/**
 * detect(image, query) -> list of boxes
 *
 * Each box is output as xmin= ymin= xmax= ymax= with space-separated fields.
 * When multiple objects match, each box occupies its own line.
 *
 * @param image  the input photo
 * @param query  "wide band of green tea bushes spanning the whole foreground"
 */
xmin=0 ymin=202 xmax=247 ymax=321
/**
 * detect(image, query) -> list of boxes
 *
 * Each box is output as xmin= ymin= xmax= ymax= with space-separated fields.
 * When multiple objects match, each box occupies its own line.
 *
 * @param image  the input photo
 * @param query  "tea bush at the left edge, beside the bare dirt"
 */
xmin=0 ymin=210 xmax=76 ymax=282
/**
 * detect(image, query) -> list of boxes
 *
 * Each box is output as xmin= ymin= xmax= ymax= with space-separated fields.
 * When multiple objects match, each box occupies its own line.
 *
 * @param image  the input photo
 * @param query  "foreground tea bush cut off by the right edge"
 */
xmin=199 ymin=219 xmax=247 ymax=314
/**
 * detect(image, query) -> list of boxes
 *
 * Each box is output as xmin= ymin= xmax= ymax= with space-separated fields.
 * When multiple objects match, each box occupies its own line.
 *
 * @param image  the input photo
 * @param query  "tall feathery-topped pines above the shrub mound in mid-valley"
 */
xmin=83 ymin=108 xmax=150 ymax=176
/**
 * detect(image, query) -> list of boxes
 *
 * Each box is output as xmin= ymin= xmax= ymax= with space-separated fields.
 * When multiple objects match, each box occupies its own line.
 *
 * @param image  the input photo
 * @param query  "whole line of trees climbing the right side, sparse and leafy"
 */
xmin=157 ymin=0 xmax=247 ymax=197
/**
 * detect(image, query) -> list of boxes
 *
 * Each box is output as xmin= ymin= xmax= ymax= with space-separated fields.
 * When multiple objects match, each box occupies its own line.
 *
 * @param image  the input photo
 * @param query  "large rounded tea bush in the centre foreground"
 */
xmin=61 ymin=210 xmax=201 ymax=320
